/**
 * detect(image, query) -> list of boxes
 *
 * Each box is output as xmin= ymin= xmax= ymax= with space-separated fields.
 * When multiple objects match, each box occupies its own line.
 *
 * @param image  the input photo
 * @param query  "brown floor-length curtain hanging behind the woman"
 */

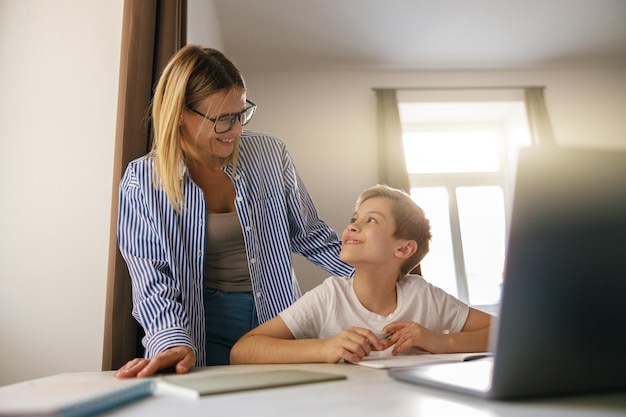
xmin=102 ymin=0 xmax=187 ymax=370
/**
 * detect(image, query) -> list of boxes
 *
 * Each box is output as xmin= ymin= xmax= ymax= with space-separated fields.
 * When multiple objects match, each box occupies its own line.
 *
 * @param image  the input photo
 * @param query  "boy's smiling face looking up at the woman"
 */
xmin=340 ymin=197 xmax=405 ymax=267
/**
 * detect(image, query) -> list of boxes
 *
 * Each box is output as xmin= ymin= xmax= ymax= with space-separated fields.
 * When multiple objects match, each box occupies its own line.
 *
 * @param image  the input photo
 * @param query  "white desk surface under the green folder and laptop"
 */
xmin=106 ymin=364 xmax=626 ymax=417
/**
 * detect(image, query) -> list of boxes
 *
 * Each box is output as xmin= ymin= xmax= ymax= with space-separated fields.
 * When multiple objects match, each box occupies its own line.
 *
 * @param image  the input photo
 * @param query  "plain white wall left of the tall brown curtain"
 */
xmin=0 ymin=0 xmax=123 ymax=385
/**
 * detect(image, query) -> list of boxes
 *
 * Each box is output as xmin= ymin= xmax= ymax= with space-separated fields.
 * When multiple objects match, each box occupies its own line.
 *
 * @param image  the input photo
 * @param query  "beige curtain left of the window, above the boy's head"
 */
xmin=376 ymin=89 xmax=411 ymax=192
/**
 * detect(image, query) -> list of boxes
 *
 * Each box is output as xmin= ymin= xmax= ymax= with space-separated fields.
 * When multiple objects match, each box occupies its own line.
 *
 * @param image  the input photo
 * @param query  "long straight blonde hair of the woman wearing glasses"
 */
xmin=150 ymin=45 xmax=246 ymax=211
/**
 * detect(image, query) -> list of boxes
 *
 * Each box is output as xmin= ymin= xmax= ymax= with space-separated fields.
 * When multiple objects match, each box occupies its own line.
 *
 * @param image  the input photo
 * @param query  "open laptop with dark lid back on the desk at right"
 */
xmin=388 ymin=147 xmax=626 ymax=399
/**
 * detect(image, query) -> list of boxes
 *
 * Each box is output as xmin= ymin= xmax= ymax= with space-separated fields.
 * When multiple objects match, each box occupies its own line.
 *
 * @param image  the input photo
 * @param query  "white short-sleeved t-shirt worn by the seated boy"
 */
xmin=280 ymin=275 xmax=469 ymax=346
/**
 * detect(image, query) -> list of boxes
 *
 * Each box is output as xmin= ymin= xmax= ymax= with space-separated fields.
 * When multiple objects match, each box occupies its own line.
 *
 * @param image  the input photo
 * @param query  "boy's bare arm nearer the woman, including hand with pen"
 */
xmin=230 ymin=316 xmax=383 ymax=365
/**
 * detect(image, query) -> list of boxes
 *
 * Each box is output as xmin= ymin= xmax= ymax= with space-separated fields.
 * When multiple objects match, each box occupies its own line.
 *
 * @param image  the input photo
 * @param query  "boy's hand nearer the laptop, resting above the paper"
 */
xmin=383 ymin=322 xmax=447 ymax=356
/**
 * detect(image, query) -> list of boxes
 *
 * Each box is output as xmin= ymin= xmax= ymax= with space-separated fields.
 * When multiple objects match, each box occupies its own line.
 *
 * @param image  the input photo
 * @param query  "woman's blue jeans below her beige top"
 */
xmin=204 ymin=288 xmax=259 ymax=365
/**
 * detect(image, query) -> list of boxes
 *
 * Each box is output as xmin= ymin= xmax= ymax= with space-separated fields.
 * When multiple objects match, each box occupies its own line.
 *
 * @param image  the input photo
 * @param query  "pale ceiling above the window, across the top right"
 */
xmin=214 ymin=0 xmax=626 ymax=71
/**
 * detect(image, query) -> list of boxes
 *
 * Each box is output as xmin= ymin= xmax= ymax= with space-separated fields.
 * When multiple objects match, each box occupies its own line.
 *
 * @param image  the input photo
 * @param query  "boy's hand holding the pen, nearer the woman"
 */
xmin=322 ymin=327 xmax=389 ymax=363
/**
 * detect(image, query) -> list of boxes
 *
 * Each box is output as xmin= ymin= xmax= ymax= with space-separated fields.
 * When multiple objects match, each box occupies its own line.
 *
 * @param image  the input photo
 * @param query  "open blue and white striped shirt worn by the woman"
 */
xmin=118 ymin=131 xmax=353 ymax=366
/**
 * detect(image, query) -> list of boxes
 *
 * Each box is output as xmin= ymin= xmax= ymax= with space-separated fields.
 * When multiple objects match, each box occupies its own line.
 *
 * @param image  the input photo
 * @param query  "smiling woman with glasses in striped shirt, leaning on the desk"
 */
xmin=116 ymin=46 xmax=352 ymax=377
